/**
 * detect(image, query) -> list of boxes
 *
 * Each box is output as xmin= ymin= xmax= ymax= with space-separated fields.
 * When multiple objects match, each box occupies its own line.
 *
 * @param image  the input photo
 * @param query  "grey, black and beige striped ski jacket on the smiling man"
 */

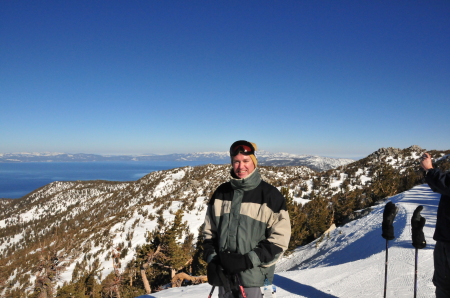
xmin=203 ymin=168 xmax=291 ymax=287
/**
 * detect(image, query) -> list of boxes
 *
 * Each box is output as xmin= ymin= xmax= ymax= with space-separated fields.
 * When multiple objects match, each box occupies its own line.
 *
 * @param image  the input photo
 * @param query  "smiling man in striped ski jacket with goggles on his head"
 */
xmin=203 ymin=141 xmax=291 ymax=298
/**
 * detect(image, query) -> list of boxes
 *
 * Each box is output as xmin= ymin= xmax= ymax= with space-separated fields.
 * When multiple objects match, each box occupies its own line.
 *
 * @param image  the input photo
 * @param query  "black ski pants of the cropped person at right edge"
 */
xmin=433 ymin=241 xmax=450 ymax=298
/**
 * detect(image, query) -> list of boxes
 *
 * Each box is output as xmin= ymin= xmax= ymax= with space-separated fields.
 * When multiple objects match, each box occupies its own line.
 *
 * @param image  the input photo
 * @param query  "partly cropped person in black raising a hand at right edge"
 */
xmin=420 ymin=153 xmax=450 ymax=298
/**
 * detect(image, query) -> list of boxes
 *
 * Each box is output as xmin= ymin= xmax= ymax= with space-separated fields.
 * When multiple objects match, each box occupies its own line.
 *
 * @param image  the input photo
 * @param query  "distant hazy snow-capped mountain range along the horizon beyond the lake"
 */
xmin=0 ymin=151 xmax=354 ymax=171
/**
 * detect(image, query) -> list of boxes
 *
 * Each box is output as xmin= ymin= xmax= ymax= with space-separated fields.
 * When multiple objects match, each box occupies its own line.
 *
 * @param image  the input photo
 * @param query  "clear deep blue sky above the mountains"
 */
xmin=0 ymin=0 xmax=450 ymax=158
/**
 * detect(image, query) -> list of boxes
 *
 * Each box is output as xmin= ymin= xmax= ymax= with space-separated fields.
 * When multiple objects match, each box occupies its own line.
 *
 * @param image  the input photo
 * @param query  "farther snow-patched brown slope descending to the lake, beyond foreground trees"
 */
xmin=0 ymin=164 xmax=315 ymax=297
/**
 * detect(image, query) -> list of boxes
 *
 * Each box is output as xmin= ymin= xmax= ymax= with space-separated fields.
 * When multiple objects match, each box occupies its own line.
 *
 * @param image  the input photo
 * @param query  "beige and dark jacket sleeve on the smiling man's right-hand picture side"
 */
xmin=249 ymin=194 xmax=291 ymax=267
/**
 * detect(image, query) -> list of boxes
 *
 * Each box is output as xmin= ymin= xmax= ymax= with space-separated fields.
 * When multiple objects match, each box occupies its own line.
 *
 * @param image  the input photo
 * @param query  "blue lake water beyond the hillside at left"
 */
xmin=0 ymin=161 xmax=218 ymax=199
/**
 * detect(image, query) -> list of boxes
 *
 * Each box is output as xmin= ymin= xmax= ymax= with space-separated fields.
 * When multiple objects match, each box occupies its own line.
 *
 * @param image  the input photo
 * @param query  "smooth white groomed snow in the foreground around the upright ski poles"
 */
xmin=139 ymin=184 xmax=440 ymax=298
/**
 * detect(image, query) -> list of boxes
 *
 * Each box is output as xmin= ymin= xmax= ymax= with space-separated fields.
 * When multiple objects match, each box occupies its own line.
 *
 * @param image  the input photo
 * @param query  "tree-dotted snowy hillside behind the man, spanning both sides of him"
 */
xmin=0 ymin=146 xmax=450 ymax=297
